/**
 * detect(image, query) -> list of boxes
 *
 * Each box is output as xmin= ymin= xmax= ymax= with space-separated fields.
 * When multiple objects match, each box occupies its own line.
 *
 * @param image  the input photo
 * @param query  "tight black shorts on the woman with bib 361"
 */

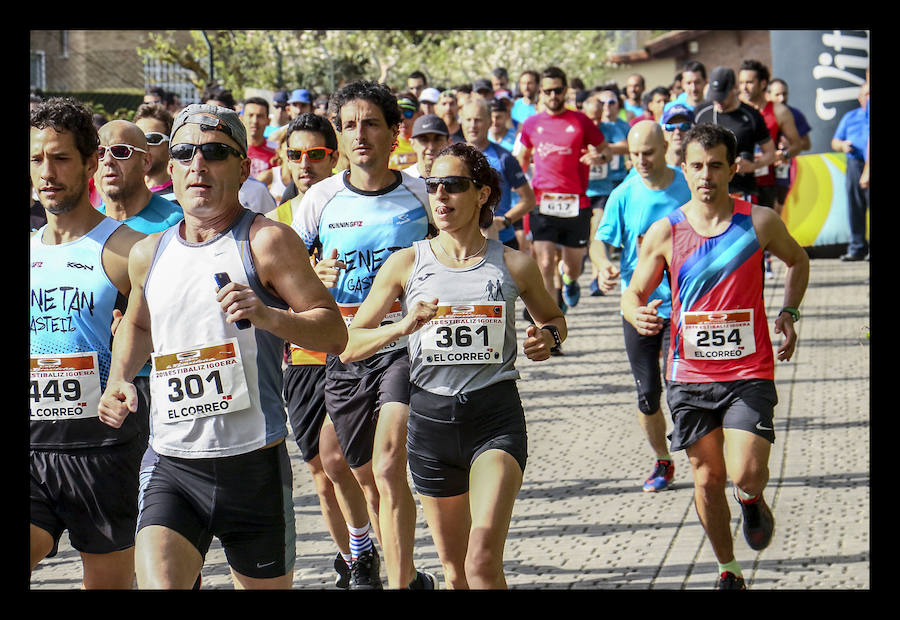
xmin=406 ymin=381 xmax=528 ymax=497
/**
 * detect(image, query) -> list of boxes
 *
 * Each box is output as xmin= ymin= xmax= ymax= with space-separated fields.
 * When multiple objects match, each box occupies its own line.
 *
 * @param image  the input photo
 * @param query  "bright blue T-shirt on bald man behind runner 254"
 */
xmin=594 ymin=166 xmax=691 ymax=318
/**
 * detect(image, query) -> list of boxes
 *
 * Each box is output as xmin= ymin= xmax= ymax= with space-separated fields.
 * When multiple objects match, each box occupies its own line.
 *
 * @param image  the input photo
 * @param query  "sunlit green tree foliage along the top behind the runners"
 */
xmin=138 ymin=30 xmax=615 ymax=97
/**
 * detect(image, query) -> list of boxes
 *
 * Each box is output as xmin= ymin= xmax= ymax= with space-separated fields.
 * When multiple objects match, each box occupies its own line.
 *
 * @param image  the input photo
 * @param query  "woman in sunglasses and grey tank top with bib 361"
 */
xmin=341 ymin=144 xmax=566 ymax=589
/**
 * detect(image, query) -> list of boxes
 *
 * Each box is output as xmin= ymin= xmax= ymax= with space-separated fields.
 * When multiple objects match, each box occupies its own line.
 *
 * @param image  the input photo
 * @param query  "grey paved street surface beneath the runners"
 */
xmin=31 ymin=259 xmax=868 ymax=590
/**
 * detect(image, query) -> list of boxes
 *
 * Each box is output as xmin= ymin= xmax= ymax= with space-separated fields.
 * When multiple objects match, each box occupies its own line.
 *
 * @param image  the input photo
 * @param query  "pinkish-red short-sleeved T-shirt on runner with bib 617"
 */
xmin=521 ymin=109 xmax=604 ymax=209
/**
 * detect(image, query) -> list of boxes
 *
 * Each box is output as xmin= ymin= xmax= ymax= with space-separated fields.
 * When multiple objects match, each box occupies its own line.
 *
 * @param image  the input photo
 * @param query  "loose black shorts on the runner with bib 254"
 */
xmin=666 ymin=379 xmax=778 ymax=450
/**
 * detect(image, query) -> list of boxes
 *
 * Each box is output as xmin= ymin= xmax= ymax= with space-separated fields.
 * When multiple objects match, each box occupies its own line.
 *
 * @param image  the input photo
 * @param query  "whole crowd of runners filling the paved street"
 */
xmin=30 ymin=52 xmax=868 ymax=589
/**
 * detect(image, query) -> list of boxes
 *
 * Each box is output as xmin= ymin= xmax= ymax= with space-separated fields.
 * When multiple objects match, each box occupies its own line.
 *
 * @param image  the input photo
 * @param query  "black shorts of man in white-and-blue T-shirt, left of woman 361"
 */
xmin=325 ymin=347 xmax=409 ymax=469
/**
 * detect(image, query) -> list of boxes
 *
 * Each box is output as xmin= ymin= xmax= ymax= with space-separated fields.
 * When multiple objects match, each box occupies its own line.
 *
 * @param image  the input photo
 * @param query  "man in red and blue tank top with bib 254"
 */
xmin=622 ymin=124 xmax=809 ymax=589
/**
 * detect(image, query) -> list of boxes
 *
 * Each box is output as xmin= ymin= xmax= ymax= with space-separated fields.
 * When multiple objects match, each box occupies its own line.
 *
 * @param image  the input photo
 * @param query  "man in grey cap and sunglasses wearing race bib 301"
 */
xmin=100 ymin=105 xmax=346 ymax=589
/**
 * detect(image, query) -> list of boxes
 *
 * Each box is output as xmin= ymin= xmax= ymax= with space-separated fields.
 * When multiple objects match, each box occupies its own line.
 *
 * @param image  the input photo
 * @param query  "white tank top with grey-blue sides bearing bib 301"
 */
xmin=144 ymin=209 xmax=288 ymax=458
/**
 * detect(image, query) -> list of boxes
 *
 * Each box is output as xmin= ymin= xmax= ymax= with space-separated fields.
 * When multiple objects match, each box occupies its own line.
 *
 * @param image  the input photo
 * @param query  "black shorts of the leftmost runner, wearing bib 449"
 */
xmin=30 ymin=436 xmax=147 ymax=557
